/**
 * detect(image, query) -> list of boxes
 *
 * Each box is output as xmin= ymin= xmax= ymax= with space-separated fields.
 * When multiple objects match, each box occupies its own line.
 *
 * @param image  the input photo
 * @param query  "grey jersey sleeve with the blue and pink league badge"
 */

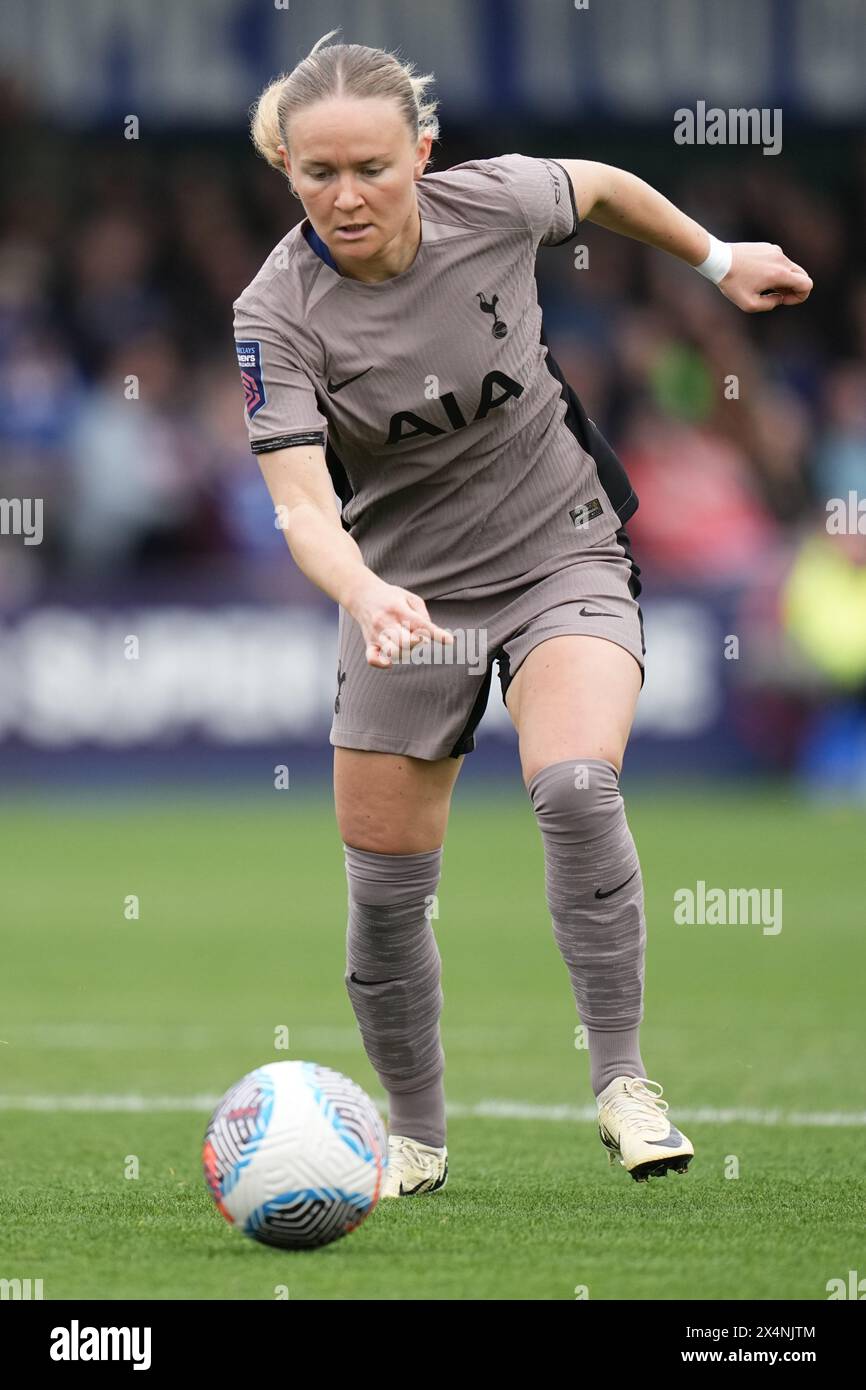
xmin=235 ymin=303 xmax=328 ymax=453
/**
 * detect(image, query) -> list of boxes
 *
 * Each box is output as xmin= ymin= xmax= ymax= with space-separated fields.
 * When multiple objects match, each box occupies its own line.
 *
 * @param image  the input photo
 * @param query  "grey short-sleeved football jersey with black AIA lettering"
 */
xmin=234 ymin=154 xmax=637 ymax=599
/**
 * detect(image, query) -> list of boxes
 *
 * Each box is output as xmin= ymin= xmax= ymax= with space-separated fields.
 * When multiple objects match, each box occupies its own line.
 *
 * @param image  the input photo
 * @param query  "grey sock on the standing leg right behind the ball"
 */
xmin=343 ymin=844 xmax=445 ymax=1148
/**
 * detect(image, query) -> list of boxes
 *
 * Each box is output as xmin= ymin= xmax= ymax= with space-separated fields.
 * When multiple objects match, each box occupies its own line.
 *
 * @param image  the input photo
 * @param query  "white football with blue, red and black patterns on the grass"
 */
xmin=202 ymin=1062 xmax=388 ymax=1250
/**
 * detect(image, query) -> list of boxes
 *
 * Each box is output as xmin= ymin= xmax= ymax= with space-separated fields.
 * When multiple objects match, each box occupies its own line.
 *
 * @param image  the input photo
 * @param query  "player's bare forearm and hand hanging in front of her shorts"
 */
xmin=257 ymin=445 xmax=453 ymax=667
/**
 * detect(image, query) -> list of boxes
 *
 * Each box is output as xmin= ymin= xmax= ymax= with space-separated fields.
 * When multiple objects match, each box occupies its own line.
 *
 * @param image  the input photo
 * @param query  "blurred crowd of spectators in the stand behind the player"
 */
xmin=0 ymin=125 xmax=866 ymax=603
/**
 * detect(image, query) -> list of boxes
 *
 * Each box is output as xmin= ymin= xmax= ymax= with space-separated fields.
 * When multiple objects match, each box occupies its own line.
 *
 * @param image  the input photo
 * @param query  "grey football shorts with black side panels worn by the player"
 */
xmin=331 ymin=527 xmax=646 ymax=760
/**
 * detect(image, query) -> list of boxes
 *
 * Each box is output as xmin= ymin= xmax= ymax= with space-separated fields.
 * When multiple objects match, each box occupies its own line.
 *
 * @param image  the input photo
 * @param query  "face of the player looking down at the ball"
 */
xmin=284 ymin=97 xmax=432 ymax=265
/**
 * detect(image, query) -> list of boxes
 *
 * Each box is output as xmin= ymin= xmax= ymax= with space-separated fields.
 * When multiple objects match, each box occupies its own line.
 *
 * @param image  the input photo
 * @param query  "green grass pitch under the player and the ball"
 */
xmin=0 ymin=780 xmax=866 ymax=1300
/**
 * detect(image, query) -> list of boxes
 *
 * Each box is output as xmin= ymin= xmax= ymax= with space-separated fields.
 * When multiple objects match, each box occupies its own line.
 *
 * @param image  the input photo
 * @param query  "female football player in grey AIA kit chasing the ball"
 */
xmin=235 ymin=29 xmax=812 ymax=1197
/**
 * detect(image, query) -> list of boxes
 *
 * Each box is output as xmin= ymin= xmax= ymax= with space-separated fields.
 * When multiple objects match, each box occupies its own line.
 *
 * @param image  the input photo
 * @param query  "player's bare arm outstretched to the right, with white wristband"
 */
xmin=547 ymin=160 xmax=812 ymax=314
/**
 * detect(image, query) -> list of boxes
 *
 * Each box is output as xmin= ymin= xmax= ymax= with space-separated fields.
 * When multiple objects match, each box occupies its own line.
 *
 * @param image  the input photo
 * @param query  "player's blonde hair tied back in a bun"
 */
xmin=250 ymin=29 xmax=439 ymax=192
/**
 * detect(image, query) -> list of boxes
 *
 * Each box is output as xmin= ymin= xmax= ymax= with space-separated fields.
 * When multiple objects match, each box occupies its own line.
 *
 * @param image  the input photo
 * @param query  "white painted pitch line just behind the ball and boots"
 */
xmin=0 ymin=1094 xmax=866 ymax=1129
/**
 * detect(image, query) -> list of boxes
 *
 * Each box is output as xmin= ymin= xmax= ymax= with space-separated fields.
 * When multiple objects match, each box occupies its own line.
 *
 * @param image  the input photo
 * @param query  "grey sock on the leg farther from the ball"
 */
xmin=528 ymin=758 xmax=646 ymax=1095
